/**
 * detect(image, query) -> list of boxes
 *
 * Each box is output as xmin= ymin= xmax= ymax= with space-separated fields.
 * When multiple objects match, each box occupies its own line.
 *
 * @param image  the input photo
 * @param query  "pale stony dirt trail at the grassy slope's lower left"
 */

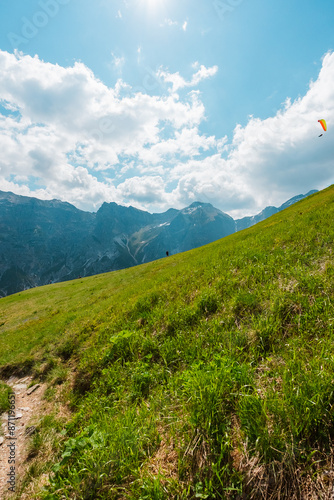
xmin=0 ymin=377 xmax=46 ymax=499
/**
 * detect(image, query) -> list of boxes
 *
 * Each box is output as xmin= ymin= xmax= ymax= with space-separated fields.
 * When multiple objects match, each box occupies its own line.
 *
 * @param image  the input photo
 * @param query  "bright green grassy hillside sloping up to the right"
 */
xmin=0 ymin=186 xmax=334 ymax=500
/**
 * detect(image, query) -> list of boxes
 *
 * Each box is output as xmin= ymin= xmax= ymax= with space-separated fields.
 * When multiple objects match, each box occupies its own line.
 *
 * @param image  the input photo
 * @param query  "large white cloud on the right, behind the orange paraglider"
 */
xmin=171 ymin=53 xmax=334 ymax=217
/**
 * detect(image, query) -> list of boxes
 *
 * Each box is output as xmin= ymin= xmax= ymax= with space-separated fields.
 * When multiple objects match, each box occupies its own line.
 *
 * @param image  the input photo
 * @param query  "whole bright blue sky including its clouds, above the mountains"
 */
xmin=0 ymin=0 xmax=334 ymax=218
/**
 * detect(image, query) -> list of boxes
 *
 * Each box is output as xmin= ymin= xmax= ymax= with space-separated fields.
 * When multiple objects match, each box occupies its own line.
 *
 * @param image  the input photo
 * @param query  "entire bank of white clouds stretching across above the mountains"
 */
xmin=0 ymin=51 xmax=334 ymax=217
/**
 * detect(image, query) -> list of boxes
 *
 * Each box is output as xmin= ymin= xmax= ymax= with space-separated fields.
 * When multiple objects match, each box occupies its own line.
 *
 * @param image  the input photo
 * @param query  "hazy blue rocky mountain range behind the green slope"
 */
xmin=0 ymin=190 xmax=316 ymax=297
